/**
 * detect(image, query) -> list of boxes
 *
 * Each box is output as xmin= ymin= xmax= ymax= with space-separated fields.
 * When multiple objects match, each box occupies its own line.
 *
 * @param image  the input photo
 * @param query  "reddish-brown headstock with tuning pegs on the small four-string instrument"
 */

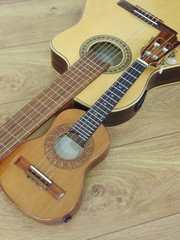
xmin=140 ymin=32 xmax=180 ymax=66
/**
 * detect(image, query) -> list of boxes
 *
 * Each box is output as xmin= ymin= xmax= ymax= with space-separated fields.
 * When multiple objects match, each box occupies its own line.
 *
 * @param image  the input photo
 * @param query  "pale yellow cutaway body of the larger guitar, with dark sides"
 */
xmin=51 ymin=0 xmax=180 ymax=125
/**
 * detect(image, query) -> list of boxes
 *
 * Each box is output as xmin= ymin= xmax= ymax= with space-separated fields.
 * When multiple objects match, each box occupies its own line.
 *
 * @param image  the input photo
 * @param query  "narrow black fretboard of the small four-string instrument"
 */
xmin=70 ymin=59 xmax=147 ymax=146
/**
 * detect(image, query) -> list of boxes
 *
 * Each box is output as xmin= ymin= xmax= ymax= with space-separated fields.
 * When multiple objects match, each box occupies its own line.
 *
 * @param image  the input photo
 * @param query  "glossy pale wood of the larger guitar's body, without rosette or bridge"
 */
xmin=51 ymin=0 xmax=180 ymax=126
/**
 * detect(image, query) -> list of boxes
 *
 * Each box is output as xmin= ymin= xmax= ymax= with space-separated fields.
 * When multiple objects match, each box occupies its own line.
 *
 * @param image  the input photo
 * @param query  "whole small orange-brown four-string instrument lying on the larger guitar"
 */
xmin=1 ymin=32 xmax=180 ymax=222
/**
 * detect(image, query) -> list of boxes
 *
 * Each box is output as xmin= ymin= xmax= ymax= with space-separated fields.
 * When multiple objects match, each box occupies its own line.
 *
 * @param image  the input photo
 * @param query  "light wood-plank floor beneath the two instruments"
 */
xmin=0 ymin=0 xmax=180 ymax=240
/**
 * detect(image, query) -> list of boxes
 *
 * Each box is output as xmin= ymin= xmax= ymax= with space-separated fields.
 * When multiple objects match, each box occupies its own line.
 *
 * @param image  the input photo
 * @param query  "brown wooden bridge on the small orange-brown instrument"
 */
xmin=15 ymin=156 xmax=65 ymax=200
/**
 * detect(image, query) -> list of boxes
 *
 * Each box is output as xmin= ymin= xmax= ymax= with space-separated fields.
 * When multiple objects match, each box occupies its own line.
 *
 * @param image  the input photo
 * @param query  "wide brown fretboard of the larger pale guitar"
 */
xmin=0 ymin=52 xmax=109 ymax=160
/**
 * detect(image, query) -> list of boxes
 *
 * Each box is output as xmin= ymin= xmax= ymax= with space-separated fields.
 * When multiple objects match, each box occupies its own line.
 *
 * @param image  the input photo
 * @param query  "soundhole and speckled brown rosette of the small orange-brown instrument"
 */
xmin=44 ymin=124 xmax=94 ymax=169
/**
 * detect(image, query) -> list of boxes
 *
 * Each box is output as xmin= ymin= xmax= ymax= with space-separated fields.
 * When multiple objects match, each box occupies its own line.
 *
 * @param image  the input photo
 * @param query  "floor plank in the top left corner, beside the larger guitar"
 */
xmin=0 ymin=0 xmax=86 ymax=48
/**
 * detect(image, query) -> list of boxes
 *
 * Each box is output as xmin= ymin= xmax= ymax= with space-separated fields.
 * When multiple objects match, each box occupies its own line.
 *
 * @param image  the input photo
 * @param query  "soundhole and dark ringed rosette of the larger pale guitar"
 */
xmin=80 ymin=35 xmax=132 ymax=73
